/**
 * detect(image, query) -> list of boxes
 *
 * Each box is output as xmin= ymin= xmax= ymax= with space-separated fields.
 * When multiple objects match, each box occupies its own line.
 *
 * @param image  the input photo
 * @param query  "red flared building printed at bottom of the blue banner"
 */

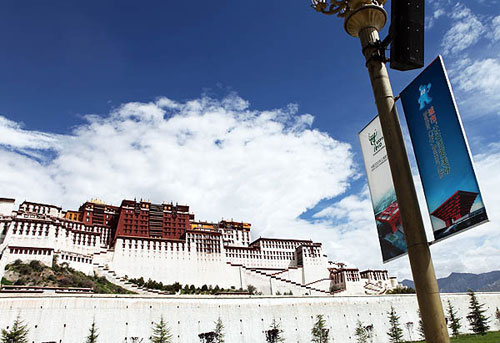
xmin=431 ymin=191 xmax=478 ymax=227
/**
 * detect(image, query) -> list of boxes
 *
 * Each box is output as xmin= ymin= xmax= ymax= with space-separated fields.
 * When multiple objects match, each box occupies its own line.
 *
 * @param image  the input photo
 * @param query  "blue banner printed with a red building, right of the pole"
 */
xmin=401 ymin=56 xmax=488 ymax=241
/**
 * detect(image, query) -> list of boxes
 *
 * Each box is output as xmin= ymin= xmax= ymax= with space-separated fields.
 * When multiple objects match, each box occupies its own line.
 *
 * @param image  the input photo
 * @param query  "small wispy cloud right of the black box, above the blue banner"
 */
xmin=441 ymin=3 xmax=485 ymax=55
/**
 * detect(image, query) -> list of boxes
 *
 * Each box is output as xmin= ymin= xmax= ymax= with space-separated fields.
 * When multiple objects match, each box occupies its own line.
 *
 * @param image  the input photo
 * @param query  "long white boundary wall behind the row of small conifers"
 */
xmin=0 ymin=293 xmax=500 ymax=343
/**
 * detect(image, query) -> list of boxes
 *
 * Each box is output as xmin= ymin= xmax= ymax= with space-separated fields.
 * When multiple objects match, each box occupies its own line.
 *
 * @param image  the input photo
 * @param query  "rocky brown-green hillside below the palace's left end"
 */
xmin=2 ymin=260 xmax=133 ymax=294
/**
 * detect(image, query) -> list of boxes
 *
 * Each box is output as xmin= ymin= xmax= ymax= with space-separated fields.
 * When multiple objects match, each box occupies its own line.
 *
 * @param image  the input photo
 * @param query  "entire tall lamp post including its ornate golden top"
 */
xmin=311 ymin=0 xmax=450 ymax=343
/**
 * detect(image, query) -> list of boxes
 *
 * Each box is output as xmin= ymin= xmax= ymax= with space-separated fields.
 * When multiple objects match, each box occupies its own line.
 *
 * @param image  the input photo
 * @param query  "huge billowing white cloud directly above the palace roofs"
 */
xmin=0 ymin=95 xmax=356 ymax=251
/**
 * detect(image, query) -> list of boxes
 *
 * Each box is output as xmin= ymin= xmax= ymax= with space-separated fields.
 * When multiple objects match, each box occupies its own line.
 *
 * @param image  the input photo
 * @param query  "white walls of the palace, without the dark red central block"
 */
xmin=0 ymin=202 xmax=397 ymax=295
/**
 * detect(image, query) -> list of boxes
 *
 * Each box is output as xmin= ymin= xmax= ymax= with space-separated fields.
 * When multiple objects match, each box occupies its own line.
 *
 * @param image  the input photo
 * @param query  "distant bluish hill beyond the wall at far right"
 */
xmin=401 ymin=270 xmax=500 ymax=293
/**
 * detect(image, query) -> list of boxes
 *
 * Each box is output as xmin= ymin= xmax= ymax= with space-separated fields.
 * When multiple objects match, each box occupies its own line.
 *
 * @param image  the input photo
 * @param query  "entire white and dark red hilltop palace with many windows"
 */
xmin=0 ymin=198 xmax=397 ymax=295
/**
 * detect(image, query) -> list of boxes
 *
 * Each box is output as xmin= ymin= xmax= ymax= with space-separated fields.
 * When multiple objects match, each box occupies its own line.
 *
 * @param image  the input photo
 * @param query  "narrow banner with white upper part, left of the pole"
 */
xmin=359 ymin=116 xmax=406 ymax=263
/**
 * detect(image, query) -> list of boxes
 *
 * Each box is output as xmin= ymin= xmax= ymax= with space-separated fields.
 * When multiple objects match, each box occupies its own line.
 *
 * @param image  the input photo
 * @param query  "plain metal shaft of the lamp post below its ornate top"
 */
xmin=359 ymin=26 xmax=450 ymax=343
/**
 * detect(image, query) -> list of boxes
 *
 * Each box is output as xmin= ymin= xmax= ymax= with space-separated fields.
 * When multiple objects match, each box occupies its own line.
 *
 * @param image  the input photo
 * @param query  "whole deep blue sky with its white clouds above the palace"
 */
xmin=0 ymin=0 xmax=500 ymax=277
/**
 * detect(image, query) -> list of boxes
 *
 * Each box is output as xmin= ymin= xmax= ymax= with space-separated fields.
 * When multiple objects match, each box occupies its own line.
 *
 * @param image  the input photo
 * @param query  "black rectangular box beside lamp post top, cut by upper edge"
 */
xmin=390 ymin=0 xmax=425 ymax=70
